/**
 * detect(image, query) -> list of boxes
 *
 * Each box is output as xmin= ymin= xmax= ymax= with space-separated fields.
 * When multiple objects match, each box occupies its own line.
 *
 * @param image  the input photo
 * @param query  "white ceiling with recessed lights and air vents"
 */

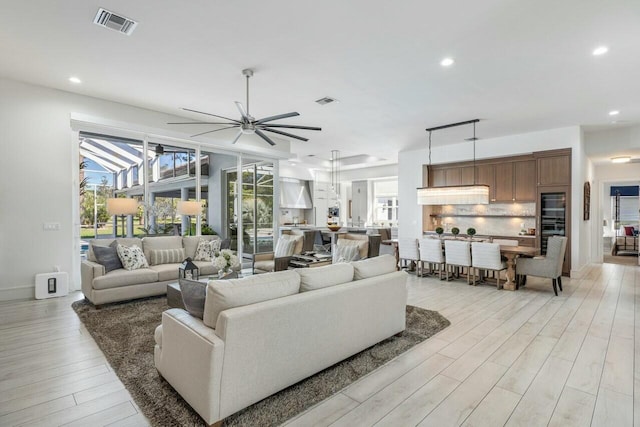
xmin=0 ymin=0 xmax=640 ymax=167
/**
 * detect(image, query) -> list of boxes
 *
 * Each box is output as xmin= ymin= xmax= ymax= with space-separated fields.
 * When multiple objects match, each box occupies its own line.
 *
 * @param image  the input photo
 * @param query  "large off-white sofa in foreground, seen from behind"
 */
xmin=154 ymin=255 xmax=407 ymax=424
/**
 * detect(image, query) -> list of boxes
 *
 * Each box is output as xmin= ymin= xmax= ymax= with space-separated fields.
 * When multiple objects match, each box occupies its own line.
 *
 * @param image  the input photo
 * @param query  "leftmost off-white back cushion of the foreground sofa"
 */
xmin=203 ymin=271 xmax=300 ymax=329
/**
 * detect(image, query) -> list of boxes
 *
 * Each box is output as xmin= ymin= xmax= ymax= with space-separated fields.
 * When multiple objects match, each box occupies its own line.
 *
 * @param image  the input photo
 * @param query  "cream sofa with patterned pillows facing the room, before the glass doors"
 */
xmin=81 ymin=236 xmax=219 ymax=305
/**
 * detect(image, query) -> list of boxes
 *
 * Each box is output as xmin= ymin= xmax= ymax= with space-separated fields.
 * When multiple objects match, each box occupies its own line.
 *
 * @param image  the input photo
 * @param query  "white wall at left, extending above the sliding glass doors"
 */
xmin=0 ymin=79 xmax=289 ymax=300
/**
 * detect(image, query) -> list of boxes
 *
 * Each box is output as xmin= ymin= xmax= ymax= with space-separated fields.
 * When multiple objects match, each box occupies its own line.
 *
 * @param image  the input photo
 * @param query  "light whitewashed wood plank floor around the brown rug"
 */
xmin=0 ymin=264 xmax=640 ymax=427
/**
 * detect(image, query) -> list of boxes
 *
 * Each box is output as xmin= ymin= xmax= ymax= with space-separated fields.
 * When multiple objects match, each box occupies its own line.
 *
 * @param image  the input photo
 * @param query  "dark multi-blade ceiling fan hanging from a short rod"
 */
xmin=167 ymin=68 xmax=322 ymax=146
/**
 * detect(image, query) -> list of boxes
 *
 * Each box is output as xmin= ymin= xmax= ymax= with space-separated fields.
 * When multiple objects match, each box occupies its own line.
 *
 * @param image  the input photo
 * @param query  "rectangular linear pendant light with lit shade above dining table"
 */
xmin=418 ymin=119 xmax=489 ymax=205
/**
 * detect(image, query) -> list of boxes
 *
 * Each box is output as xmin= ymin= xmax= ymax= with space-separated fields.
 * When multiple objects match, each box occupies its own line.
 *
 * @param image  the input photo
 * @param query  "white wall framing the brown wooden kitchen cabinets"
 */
xmin=398 ymin=126 xmax=590 ymax=272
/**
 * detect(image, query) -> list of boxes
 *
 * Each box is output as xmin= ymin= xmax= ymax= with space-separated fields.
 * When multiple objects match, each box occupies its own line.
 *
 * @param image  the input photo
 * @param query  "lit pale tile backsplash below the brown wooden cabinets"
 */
xmin=429 ymin=203 xmax=536 ymax=236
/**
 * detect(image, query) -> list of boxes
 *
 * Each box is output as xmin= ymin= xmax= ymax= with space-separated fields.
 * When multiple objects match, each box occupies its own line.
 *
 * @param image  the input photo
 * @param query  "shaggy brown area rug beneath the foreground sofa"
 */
xmin=72 ymin=297 xmax=449 ymax=426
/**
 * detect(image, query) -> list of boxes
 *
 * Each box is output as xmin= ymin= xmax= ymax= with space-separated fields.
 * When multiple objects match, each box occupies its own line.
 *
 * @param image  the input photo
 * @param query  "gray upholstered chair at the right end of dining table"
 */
xmin=516 ymin=236 xmax=567 ymax=295
